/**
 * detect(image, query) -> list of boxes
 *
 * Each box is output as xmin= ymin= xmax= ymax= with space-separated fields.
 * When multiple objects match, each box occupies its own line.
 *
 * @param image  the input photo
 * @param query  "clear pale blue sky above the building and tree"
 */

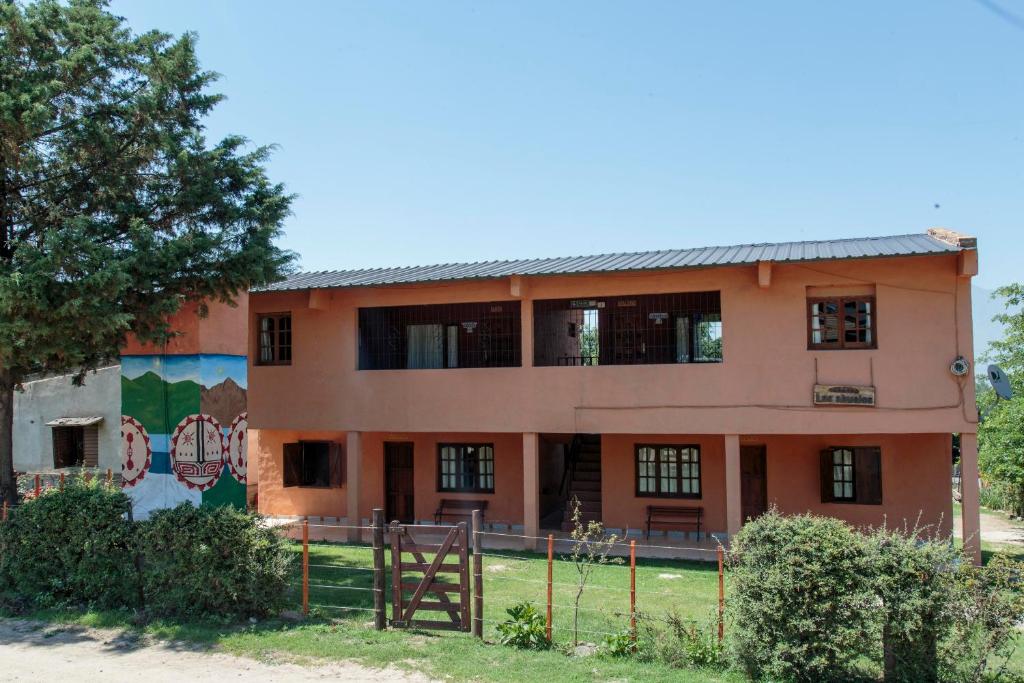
xmin=112 ymin=0 xmax=1024 ymax=289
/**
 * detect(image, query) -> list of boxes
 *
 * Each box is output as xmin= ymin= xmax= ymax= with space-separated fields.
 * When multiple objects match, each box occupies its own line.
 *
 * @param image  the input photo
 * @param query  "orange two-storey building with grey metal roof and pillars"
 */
xmin=249 ymin=229 xmax=980 ymax=555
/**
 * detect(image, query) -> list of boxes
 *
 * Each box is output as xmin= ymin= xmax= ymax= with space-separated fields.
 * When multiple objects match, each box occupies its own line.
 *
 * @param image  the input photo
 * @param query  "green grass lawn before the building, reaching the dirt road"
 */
xmin=16 ymin=544 xmax=743 ymax=683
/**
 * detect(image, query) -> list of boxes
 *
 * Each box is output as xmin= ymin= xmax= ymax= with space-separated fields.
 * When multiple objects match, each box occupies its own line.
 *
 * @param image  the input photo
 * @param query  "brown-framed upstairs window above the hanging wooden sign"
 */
xmin=807 ymin=296 xmax=878 ymax=349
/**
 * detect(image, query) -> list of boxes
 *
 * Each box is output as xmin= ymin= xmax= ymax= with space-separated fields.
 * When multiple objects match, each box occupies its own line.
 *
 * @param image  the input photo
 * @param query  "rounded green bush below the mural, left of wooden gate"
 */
xmin=139 ymin=503 xmax=294 ymax=617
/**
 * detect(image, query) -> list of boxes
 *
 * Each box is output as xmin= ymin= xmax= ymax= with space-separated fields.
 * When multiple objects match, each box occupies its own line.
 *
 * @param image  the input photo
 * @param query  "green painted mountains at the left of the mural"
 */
xmin=121 ymin=372 xmax=200 ymax=434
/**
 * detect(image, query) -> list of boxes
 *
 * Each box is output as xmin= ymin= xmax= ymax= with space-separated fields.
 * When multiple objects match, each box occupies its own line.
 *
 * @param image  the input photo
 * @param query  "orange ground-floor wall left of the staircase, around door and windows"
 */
xmin=249 ymin=429 xmax=522 ymax=524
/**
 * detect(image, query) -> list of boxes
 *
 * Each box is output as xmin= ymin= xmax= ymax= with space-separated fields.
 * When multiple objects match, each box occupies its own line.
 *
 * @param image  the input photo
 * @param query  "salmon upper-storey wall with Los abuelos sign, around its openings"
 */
xmin=248 ymin=254 xmax=976 ymax=434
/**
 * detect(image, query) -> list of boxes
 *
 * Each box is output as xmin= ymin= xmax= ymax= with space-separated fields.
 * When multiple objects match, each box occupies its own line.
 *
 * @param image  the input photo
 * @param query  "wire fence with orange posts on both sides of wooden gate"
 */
xmin=268 ymin=511 xmax=725 ymax=642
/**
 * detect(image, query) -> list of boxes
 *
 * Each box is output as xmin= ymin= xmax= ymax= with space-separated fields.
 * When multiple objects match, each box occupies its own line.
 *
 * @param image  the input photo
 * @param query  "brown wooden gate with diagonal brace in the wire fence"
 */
xmin=389 ymin=522 xmax=470 ymax=631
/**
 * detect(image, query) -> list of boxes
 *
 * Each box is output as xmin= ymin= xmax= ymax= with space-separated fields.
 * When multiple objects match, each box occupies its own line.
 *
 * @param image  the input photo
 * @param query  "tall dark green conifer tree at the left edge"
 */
xmin=0 ymin=0 xmax=292 ymax=500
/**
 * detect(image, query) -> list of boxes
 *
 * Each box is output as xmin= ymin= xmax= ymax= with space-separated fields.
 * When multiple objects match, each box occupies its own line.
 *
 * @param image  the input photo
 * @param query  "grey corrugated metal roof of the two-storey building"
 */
xmin=261 ymin=233 xmax=961 ymax=292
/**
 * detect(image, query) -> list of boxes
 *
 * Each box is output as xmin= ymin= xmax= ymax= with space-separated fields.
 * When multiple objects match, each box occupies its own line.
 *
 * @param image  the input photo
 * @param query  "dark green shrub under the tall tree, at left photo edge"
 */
xmin=0 ymin=479 xmax=139 ymax=608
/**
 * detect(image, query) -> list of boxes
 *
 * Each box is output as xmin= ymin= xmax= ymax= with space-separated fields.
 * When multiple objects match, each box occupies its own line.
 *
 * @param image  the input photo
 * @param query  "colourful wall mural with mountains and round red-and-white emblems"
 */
xmin=121 ymin=353 xmax=248 ymax=518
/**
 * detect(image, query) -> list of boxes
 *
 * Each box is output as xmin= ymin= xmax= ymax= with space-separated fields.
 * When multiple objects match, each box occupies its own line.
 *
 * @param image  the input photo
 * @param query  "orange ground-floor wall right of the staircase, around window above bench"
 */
xmin=601 ymin=434 xmax=726 ymax=532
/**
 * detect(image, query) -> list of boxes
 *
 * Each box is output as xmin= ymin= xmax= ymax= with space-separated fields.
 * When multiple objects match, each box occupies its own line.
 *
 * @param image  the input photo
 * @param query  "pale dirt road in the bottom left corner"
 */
xmin=0 ymin=620 xmax=429 ymax=683
